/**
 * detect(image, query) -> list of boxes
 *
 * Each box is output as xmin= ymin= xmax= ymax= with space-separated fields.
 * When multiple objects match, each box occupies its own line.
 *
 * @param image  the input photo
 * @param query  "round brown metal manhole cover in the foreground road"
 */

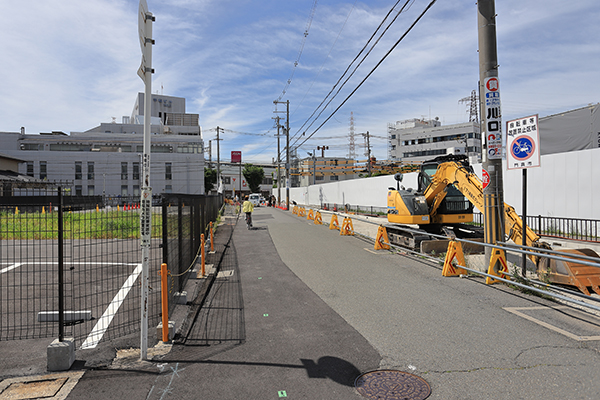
xmin=354 ymin=369 xmax=431 ymax=400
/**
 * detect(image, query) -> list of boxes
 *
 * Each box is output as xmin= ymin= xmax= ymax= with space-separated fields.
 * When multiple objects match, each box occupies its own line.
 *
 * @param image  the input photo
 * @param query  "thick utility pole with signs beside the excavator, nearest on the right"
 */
xmin=477 ymin=0 xmax=504 ymax=269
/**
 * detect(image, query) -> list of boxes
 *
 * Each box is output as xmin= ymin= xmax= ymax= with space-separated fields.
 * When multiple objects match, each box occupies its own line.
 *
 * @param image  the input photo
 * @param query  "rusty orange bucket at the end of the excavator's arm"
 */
xmin=538 ymin=249 xmax=600 ymax=296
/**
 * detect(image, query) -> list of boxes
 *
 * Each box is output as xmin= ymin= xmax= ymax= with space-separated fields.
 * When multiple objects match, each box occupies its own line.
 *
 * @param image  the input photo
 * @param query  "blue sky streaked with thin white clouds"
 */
xmin=0 ymin=0 xmax=600 ymax=163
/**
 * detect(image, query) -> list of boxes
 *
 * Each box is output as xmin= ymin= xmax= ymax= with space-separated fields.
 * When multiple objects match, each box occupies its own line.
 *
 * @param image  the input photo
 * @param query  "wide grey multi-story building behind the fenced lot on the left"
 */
xmin=0 ymin=93 xmax=204 ymax=196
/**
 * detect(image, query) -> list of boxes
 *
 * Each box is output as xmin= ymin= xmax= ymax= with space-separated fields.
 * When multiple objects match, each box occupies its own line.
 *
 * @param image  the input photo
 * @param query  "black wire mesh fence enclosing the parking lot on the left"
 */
xmin=0 ymin=187 xmax=222 ymax=348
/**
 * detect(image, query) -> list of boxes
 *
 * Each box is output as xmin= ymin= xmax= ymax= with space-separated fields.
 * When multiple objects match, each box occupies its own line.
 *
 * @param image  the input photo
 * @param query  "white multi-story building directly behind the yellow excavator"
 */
xmin=388 ymin=118 xmax=481 ymax=163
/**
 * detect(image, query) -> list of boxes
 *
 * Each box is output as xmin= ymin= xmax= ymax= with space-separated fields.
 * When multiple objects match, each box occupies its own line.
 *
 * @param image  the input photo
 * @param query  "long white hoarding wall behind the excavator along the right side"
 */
xmin=282 ymin=149 xmax=600 ymax=219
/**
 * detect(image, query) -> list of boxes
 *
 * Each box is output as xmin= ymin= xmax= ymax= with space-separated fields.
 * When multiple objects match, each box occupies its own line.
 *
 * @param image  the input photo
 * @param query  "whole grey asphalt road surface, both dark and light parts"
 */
xmin=1 ymin=207 xmax=600 ymax=400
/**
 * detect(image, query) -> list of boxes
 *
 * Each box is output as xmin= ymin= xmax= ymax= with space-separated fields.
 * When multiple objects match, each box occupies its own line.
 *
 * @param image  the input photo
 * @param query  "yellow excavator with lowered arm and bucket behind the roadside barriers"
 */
xmin=386 ymin=155 xmax=600 ymax=295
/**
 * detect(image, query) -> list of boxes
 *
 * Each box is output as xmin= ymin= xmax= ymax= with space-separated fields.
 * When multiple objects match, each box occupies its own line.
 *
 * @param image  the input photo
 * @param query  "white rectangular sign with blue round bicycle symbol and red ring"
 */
xmin=506 ymin=114 xmax=540 ymax=169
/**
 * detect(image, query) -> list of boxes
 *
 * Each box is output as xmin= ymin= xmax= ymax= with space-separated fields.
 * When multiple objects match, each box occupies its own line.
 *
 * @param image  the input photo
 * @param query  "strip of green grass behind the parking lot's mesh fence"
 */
xmin=0 ymin=210 xmax=162 ymax=240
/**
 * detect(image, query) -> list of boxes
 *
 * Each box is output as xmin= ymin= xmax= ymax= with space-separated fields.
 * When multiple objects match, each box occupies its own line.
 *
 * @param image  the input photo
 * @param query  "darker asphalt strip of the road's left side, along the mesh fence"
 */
xmin=61 ymin=205 xmax=380 ymax=400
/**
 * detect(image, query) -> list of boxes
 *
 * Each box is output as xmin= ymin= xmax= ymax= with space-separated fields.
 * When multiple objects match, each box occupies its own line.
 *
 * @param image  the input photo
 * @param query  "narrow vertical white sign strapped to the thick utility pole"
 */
xmin=483 ymin=77 xmax=503 ymax=160
